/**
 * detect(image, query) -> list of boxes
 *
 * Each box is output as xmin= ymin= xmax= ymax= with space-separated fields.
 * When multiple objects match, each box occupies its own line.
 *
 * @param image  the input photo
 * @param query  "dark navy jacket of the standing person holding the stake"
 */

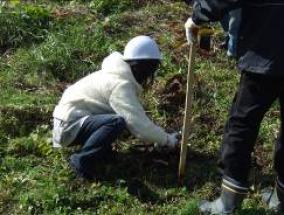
xmin=192 ymin=0 xmax=284 ymax=77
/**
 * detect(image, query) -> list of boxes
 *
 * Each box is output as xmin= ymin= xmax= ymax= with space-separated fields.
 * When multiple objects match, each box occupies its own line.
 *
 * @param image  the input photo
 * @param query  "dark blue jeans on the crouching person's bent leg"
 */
xmin=70 ymin=114 xmax=126 ymax=178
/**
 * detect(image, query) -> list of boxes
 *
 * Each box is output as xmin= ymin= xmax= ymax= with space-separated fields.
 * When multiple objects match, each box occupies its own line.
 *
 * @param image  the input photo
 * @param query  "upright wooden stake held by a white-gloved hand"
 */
xmin=178 ymin=44 xmax=195 ymax=185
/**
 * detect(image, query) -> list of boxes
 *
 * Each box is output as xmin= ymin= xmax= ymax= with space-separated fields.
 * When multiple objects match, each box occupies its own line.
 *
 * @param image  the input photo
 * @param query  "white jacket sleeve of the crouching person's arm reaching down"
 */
xmin=109 ymin=83 xmax=167 ymax=145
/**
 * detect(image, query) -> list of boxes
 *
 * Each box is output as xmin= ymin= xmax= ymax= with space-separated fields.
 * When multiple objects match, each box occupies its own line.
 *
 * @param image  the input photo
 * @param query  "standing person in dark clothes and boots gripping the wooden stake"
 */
xmin=185 ymin=0 xmax=284 ymax=214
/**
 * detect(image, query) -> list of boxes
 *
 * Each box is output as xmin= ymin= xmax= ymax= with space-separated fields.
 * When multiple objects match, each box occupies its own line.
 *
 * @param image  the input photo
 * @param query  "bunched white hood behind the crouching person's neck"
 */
xmin=102 ymin=52 xmax=142 ymax=90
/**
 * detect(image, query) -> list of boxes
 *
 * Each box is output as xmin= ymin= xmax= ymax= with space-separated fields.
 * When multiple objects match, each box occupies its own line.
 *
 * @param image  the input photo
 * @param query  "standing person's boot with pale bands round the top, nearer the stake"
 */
xmin=199 ymin=179 xmax=248 ymax=215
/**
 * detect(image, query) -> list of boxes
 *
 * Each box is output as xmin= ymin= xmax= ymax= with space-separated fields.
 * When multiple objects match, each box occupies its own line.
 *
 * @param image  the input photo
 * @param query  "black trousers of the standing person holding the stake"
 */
xmin=219 ymin=73 xmax=284 ymax=186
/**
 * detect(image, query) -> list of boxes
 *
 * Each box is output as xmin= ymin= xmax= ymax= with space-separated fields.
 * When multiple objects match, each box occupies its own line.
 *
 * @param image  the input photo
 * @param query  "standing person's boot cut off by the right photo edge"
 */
xmin=262 ymin=180 xmax=284 ymax=213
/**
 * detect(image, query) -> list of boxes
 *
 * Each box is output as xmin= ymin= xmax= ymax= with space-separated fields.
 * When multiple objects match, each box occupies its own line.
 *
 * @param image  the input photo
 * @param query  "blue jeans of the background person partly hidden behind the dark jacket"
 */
xmin=221 ymin=9 xmax=242 ymax=57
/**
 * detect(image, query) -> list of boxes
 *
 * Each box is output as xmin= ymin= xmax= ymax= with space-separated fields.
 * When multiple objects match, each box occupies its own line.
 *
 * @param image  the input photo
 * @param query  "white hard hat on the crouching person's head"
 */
xmin=123 ymin=36 xmax=161 ymax=60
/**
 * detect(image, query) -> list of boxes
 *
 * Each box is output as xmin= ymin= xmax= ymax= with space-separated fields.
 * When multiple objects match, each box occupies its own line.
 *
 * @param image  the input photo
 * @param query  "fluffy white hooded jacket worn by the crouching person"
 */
xmin=53 ymin=52 xmax=167 ymax=145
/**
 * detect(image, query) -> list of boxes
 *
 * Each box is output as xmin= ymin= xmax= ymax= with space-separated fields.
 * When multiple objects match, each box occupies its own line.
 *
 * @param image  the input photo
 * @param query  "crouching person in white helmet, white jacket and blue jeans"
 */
xmin=53 ymin=36 xmax=178 ymax=179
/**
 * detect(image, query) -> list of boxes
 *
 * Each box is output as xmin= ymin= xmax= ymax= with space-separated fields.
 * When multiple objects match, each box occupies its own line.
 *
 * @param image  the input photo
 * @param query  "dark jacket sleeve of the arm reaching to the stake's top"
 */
xmin=192 ymin=0 xmax=242 ymax=25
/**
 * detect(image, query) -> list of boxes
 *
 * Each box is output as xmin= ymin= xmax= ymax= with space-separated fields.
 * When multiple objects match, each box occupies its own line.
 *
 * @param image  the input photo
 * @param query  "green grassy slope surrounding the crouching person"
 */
xmin=0 ymin=0 xmax=279 ymax=214
